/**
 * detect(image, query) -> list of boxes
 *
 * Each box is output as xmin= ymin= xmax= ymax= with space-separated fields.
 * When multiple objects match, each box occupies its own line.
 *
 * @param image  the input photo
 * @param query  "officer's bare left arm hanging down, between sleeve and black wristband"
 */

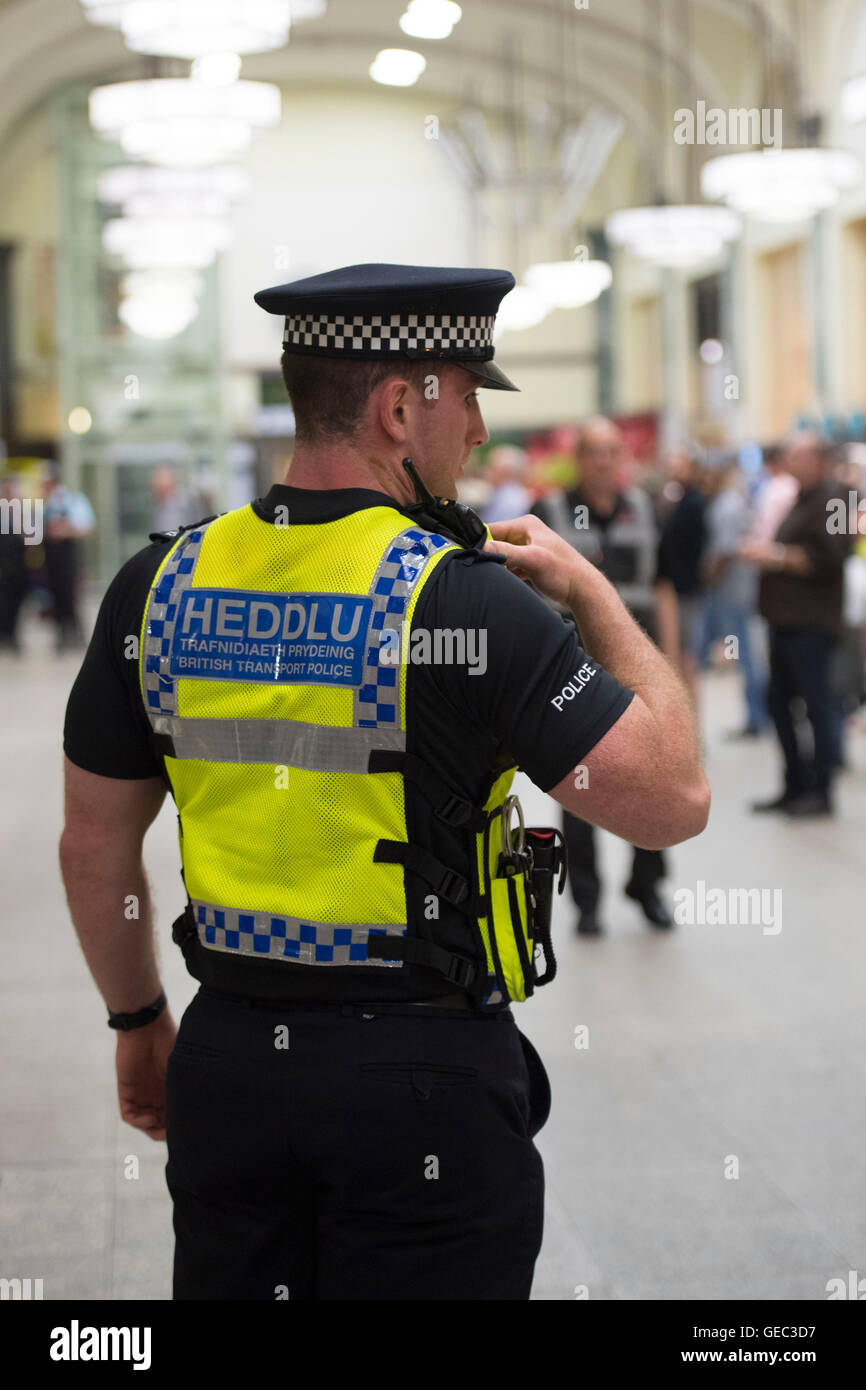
xmin=60 ymin=758 xmax=165 ymax=1013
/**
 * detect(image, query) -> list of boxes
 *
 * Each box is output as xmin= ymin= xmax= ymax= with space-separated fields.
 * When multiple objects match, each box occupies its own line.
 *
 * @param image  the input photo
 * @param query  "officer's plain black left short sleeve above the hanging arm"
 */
xmin=63 ymin=543 xmax=165 ymax=780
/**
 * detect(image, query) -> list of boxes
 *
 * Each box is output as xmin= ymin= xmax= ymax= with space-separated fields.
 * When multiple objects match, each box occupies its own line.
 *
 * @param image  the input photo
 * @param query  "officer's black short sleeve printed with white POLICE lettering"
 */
xmin=413 ymin=556 xmax=634 ymax=791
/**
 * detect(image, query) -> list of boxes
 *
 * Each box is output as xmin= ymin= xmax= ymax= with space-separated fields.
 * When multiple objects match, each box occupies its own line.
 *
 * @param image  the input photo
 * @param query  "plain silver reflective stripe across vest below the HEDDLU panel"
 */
xmin=153 ymin=714 xmax=406 ymax=773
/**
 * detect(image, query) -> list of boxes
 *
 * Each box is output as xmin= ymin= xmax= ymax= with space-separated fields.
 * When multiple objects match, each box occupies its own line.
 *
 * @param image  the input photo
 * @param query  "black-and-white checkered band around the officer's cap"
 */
xmin=282 ymin=314 xmax=496 ymax=361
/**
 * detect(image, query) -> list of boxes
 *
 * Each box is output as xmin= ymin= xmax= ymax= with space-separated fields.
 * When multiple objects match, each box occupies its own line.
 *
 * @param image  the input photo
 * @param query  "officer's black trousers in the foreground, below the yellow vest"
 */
xmin=165 ymin=988 xmax=550 ymax=1301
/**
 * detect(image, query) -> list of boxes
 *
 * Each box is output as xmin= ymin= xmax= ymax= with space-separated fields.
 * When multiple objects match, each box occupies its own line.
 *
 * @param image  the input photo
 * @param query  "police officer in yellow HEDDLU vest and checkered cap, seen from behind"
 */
xmin=61 ymin=265 xmax=709 ymax=1300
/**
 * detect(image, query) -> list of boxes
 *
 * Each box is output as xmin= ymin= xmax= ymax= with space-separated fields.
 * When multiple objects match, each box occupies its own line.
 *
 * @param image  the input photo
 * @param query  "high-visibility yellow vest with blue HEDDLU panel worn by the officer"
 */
xmin=140 ymin=506 xmax=534 ymax=1004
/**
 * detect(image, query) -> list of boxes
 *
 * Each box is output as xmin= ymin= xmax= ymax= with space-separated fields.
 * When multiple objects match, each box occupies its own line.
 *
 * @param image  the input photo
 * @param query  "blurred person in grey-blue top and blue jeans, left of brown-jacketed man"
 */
xmin=702 ymin=459 xmax=770 ymax=738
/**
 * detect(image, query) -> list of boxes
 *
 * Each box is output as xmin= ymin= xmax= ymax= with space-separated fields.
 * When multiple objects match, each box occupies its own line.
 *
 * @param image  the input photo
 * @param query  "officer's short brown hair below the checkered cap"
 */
xmin=281 ymin=353 xmax=445 ymax=443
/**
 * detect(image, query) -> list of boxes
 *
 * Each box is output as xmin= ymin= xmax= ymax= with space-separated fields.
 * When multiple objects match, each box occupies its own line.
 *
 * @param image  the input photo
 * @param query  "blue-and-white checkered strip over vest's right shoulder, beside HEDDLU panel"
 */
xmin=352 ymin=527 xmax=453 ymax=728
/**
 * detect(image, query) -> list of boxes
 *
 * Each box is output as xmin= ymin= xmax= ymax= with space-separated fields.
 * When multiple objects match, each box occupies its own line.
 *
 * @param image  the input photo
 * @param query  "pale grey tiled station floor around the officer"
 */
xmin=0 ymin=624 xmax=866 ymax=1300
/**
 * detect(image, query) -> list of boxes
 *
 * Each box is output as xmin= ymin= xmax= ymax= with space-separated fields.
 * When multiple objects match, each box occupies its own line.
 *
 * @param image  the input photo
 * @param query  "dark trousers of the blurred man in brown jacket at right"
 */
xmin=767 ymin=626 xmax=837 ymax=796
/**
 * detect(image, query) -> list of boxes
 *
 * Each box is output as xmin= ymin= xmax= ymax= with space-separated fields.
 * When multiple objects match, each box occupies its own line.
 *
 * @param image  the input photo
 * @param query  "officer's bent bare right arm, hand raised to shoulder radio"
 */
xmin=488 ymin=516 xmax=710 ymax=849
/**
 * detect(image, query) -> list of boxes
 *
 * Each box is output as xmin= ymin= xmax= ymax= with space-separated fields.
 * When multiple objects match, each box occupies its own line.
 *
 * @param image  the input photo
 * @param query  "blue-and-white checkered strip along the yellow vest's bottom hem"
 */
xmin=190 ymin=898 xmax=406 ymax=970
